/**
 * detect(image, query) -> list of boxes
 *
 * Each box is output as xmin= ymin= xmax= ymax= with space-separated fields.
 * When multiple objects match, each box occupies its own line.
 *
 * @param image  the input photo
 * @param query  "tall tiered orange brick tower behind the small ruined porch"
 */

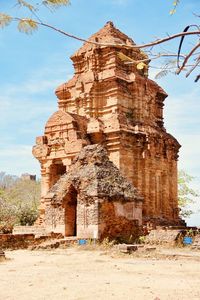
xmin=33 ymin=22 xmax=180 ymax=234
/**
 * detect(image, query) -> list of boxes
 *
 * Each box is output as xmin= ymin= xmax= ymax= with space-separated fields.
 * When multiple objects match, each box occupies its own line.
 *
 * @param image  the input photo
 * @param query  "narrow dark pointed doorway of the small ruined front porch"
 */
xmin=63 ymin=185 xmax=77 ymax=236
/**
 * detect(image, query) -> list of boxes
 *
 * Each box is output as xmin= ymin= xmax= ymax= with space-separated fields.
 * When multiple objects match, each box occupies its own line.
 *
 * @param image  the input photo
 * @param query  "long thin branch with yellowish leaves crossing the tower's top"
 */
xmin=0 ymin=10 xmax=200 ymax=76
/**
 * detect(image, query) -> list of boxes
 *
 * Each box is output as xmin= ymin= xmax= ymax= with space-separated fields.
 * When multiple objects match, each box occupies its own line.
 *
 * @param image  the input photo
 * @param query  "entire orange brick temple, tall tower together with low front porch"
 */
xmin=33 ymin=22 xmax=181 ymax=237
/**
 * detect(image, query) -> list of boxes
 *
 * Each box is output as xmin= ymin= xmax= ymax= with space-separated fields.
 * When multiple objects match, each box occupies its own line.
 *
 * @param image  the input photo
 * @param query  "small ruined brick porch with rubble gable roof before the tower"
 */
xmin=40 ymin=144 xmax=143 ymax=239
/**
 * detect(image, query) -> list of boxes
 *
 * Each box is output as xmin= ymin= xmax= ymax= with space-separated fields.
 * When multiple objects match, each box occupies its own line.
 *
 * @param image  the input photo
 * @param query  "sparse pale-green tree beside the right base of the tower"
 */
xmin=178 ymin=170 xmax=199 ymax=218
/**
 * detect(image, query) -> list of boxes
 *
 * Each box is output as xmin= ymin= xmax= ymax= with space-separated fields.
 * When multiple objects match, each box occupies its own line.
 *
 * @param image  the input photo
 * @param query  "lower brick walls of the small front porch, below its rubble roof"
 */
xmin=42 ymin=197 xmax=142 ymax=240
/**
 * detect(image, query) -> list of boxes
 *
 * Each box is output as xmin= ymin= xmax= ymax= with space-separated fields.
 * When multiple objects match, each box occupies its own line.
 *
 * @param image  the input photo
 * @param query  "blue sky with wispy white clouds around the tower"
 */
xmin=0 ymin=0 xmax=200 ymax=225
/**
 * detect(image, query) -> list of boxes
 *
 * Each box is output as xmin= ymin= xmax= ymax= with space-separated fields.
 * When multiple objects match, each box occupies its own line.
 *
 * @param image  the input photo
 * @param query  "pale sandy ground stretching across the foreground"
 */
xmin=0 ymin=248 xmax=200 ymax=300
